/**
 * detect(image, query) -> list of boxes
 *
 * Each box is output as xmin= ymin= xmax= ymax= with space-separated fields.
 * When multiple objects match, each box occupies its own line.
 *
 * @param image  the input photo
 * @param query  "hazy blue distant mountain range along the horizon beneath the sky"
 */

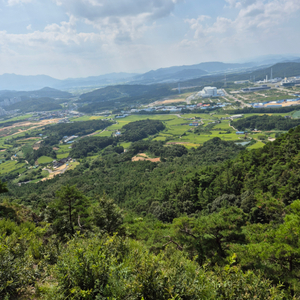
xmin=0 ymin=56 xmax=300 ymax=93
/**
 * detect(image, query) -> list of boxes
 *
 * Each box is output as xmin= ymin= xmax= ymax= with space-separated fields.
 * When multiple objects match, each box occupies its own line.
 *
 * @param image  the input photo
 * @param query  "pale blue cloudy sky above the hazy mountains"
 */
xmin=0 ymin=0 xmax=300 ymax=79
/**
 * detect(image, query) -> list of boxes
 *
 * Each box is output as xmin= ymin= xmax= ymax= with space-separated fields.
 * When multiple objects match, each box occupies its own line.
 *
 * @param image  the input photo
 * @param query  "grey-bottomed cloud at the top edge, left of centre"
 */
xmin=54 ymin=0 xmax=183 ymax=43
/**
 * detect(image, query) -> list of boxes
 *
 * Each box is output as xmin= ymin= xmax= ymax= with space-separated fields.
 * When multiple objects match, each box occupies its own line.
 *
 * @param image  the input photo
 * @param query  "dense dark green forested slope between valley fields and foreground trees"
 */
xmin=10 ymin=127 xmax=300 ymax=221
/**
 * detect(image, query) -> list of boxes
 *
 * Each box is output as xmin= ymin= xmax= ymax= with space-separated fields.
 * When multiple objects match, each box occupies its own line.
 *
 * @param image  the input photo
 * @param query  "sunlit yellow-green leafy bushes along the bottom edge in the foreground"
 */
xmin=38 ymin=236 xmax=284 ymax=300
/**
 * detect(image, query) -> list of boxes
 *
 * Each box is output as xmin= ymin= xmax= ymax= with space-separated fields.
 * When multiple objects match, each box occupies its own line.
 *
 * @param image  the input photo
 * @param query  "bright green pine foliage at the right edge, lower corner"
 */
xmin=234 ymin=200 xmax=300 ymax=296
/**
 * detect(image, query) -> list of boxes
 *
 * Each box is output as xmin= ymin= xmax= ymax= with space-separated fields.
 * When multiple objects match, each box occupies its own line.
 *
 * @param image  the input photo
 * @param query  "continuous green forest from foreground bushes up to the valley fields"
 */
xmin=0 ymin=126 xmax=300 ymax=300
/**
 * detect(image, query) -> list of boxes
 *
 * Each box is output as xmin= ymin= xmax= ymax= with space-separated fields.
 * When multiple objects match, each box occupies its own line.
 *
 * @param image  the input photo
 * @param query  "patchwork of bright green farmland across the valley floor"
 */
xmin=0 ymin=106 xmax=300 ymax=182
